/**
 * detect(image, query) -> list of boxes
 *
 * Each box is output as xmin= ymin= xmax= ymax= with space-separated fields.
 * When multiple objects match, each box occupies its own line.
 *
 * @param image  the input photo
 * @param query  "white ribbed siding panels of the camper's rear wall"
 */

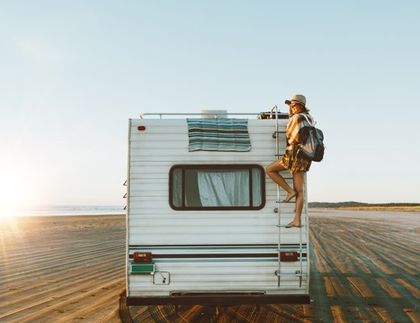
xmin=128 ymin=119 xmax=308 ymax=296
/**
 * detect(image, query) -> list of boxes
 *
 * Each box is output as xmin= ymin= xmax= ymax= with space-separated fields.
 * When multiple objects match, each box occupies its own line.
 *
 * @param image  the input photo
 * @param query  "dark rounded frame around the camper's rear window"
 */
xmin=169 ymin=164 xmax=266 ymax=211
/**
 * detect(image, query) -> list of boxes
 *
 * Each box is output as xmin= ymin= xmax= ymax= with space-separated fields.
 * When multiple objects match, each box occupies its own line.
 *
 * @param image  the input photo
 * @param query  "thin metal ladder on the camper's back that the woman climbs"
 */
xmin=270 ymin=105 xmax=308 ymax=287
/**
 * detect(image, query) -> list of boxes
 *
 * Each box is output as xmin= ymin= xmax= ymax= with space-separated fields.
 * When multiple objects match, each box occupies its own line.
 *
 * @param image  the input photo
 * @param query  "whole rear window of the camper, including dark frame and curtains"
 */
xmin=169 ymin=165 xmax=265 ymax=210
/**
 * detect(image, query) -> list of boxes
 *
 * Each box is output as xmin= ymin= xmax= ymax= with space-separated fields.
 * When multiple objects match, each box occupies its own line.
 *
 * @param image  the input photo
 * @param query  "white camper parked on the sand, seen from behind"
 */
xmin=126 ymin=108 xmax=309 ymax=305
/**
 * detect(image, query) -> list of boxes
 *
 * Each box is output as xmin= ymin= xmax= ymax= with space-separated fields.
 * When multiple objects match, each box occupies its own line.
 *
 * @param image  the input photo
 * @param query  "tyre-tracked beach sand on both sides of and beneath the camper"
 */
xmin=0 ymin=213 xmax=420 ymax=322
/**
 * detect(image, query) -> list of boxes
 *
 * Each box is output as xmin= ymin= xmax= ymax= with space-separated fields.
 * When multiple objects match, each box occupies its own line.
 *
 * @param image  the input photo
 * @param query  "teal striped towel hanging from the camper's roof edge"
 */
xmin=187 ymin=118 xmax=251 ymax=151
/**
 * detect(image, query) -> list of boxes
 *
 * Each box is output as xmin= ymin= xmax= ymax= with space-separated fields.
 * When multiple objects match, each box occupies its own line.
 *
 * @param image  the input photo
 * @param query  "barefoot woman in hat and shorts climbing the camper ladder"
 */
xmin=266 ymin=94 xmax=314 ymax=228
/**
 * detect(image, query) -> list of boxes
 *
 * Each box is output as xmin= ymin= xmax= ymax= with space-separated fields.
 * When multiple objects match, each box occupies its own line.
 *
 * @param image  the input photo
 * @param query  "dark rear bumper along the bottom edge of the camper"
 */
xmin=127 ymin=293 xmax=310 ymax=306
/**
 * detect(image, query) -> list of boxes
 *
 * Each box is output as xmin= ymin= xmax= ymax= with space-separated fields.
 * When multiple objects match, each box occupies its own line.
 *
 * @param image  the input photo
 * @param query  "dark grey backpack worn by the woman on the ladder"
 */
xmin=297 ymin=113 xmax=325 ymax=162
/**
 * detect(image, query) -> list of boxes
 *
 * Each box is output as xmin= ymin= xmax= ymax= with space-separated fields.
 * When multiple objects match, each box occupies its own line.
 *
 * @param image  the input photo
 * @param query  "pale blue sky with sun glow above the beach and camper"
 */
xmin=0 ymin=0 xmax=420 ymax=209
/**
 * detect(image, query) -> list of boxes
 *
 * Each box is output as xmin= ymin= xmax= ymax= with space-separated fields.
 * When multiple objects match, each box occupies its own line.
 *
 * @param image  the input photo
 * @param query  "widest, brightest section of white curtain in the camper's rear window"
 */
xmin=197 ymin=170 xmax=250 ymax=207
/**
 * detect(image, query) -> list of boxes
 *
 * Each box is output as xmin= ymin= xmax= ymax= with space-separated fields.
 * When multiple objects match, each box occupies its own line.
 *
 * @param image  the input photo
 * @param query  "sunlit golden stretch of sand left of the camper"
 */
xmin=0 ymin=215 xmax=125 ymax=322
